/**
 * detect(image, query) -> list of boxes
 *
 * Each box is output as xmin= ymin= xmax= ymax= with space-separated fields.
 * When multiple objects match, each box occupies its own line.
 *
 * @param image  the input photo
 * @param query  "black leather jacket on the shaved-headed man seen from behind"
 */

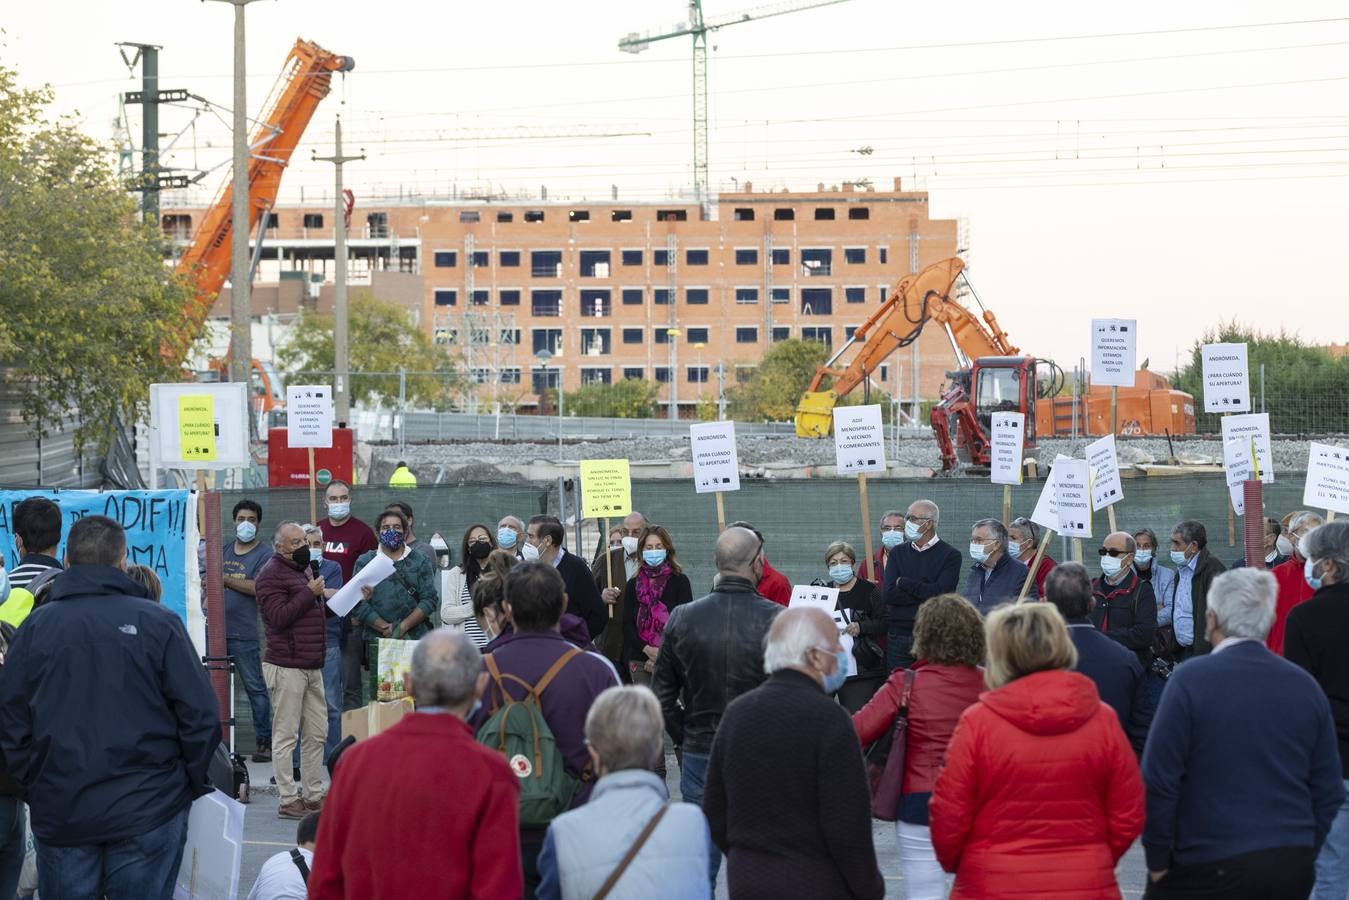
xmin=652 ymin=575 xmax=782 ymax=753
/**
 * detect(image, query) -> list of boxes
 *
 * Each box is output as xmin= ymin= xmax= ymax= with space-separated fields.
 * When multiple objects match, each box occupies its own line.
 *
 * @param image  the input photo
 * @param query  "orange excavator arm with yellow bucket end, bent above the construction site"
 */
xmin=796 ymin=256 xmax=1020 ymax=437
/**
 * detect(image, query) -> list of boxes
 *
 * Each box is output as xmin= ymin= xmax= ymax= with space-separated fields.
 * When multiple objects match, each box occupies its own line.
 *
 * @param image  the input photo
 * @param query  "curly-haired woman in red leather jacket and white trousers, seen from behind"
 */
xmin=853 ymin=594 xmax=983 ymax=900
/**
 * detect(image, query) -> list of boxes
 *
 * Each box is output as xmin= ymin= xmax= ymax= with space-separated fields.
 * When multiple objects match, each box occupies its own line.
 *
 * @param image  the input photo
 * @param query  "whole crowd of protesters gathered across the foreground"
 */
xmin=0 ymin=482 xmax=1349 ymax=900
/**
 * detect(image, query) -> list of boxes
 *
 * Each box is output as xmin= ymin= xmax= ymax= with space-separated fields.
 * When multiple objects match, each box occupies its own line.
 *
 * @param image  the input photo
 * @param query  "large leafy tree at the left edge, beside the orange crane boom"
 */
xmin=0 ymin=66 xmax=197 ymax=449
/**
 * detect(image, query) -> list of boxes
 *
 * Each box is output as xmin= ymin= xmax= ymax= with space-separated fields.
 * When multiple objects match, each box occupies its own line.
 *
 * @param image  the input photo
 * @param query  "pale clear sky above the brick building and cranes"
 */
xmin=0 ymin=0 xmax=1349 ymax=371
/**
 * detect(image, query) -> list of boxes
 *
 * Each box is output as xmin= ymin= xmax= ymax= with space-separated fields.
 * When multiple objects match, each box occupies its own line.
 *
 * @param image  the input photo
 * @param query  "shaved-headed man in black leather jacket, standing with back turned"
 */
xmin=652 ymin=528 xmax=782 ymax=882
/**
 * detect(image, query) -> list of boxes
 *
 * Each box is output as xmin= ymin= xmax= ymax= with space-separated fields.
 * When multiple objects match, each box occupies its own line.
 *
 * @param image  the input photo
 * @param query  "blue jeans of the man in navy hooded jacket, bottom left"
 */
xmin=36 ymin=806 xmax=192 ymax=900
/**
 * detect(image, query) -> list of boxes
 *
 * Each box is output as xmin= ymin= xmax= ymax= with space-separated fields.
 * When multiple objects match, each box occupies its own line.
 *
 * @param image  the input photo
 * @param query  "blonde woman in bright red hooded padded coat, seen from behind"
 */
xmin=929 ymin=603 xmax=1144 ymax=900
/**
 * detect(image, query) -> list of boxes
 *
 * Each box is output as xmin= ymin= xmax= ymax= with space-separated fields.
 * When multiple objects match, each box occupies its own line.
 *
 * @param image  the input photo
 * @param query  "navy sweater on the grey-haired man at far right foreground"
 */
xmin=1143 ymin=641 xmax=1345 ymax=872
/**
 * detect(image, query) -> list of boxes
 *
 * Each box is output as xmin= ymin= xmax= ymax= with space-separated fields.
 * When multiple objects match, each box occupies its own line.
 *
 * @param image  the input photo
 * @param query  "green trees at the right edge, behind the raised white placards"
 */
xmin=1172 ymin=321 xmax=1349 ymax=434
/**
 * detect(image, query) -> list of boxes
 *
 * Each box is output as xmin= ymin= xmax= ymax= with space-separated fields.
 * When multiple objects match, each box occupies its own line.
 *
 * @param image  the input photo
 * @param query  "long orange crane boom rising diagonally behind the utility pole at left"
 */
xmin=169 ymin=39 xmax=356 ymax=412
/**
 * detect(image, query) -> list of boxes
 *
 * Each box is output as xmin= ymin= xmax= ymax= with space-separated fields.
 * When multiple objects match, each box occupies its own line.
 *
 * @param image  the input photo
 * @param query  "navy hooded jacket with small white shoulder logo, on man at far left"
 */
xmin=0 ymin=565 xmax=220 ymax=846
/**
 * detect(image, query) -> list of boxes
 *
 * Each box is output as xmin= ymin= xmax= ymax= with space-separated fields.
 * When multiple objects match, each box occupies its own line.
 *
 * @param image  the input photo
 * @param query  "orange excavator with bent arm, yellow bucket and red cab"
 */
xmin=796 ymin=258 xmax=1194 ymax=471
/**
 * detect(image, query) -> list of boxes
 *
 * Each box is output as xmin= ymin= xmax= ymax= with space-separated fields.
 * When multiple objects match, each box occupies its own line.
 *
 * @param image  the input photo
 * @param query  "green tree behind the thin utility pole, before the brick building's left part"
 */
xmin=277 ymin=294 xmax=463 ymax=409
